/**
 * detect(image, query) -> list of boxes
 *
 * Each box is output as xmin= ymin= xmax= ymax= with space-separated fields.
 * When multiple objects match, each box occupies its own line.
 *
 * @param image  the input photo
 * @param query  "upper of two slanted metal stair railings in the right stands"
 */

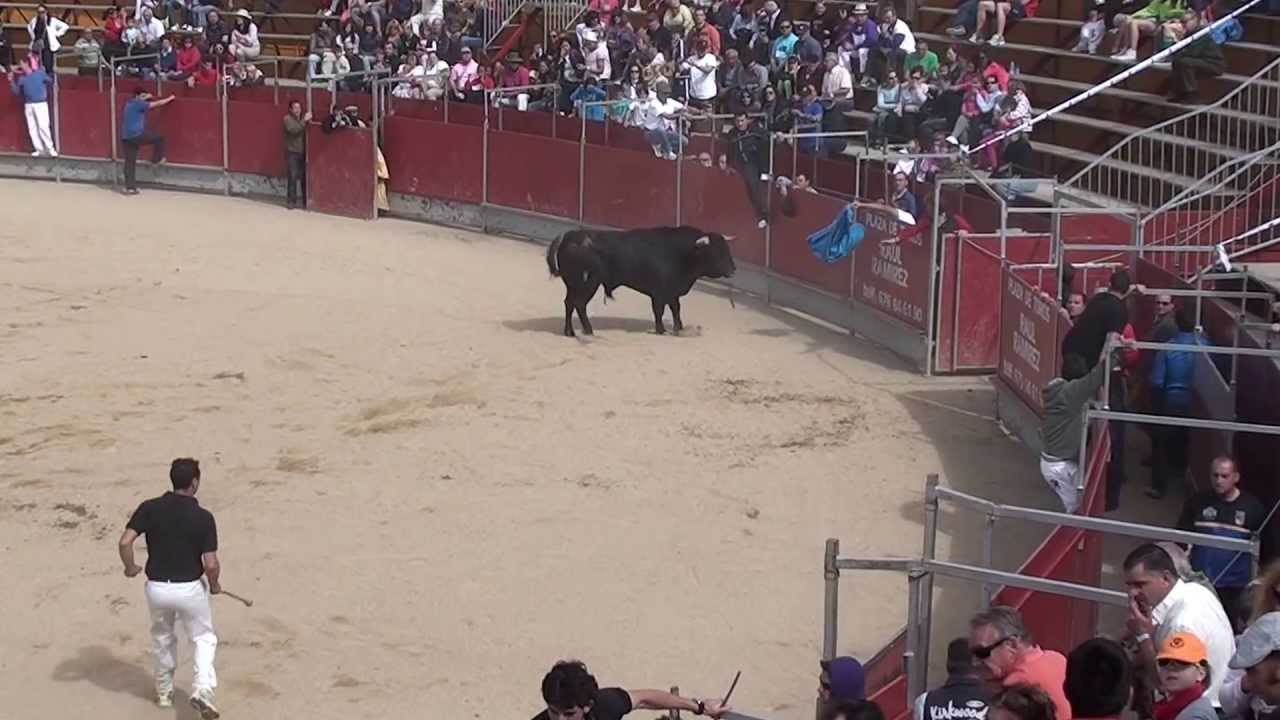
xmin=1059 ymin=59 xmax=1280 ymax=211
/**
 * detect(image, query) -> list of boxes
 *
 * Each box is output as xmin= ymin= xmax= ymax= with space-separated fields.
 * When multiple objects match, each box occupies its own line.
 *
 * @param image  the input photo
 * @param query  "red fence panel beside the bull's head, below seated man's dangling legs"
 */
xmin=680 ymin=159 xmax=768 ymax=266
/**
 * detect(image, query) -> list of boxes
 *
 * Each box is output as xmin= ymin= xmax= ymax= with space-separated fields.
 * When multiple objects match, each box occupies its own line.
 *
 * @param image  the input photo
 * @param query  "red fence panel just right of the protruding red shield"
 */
xmin=383 ymin=115 xmax=484 ymax=202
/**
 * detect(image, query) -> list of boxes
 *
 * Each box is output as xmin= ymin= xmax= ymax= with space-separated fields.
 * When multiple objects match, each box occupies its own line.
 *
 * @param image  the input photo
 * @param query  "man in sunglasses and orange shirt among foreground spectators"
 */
xmin=969 ymin=605 xmax=1071 ymax=720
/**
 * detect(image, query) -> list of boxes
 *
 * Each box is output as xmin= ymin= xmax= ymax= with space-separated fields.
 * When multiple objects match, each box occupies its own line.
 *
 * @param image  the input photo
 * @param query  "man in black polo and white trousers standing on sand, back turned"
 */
xmin=119 ymin=457 xmax=221 ymax=720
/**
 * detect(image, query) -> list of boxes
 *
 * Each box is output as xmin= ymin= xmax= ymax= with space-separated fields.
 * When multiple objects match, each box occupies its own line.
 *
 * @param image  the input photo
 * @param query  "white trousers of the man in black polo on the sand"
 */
xmin=146 ymin=580 xmax=218 ymax=693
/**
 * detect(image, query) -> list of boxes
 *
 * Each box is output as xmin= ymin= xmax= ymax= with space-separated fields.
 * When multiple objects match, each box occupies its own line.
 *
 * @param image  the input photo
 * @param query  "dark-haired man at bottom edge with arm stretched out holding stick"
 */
xmin=534 ymin=660 xmax=730 ymax=720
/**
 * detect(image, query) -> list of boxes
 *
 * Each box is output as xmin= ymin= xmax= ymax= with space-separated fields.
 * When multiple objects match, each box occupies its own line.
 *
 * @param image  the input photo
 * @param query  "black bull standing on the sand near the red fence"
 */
xmin=547 ymin=225 xmax=737 ymax=337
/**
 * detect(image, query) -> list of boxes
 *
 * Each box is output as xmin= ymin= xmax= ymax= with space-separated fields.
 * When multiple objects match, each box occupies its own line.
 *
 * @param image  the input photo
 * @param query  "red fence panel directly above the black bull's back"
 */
xmin=583 ymin=145 xmax=676 ymax=228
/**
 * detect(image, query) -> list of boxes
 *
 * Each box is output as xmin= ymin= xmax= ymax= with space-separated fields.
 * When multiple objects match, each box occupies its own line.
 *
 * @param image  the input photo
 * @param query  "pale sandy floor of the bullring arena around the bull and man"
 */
xmin=0 ymin=181 xmax=1052 ymax=720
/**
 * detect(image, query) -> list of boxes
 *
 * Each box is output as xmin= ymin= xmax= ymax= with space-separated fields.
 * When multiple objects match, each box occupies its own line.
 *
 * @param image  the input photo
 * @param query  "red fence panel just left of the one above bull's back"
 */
xmin=488 ymin=131 xmax=579 ymax=218
